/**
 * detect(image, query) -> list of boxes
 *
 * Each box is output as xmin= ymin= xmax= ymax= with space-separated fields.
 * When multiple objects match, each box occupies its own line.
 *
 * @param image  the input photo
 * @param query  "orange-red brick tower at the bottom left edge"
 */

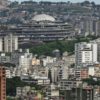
xmin=0 ymin=67 xmax=6 ymax=100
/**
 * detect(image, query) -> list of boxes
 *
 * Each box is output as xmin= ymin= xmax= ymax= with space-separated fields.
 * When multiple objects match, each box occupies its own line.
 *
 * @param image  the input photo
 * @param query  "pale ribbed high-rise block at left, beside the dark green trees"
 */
xmin=4 ymin=34 xmax=18 ymax=52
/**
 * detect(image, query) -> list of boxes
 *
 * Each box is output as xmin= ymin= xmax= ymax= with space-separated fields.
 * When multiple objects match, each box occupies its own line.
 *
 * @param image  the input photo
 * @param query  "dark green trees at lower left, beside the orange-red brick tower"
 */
xmin=6 ymin=77 xmax=43 ymax=96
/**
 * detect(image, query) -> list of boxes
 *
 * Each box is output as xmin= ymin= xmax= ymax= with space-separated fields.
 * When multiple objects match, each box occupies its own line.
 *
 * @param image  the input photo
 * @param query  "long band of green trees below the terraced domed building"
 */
xmin=30 ymin=36 xmax=96 ymax=56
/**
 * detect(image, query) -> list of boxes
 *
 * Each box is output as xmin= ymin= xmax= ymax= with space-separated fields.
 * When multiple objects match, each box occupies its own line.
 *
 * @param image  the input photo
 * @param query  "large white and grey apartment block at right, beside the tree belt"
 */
xmin=75 ymin=42 xmax=97 ymax=67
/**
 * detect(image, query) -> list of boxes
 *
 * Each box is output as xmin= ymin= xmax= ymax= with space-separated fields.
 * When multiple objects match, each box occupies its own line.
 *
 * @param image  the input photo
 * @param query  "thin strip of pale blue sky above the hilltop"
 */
xmin=10 ymin=0 xmax=100 ymax=4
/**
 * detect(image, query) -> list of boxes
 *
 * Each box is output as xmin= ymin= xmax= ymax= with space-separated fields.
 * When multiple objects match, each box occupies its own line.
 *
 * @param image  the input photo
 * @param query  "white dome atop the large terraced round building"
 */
xmin=32 ymin=14 xmax=55 ymax=22
